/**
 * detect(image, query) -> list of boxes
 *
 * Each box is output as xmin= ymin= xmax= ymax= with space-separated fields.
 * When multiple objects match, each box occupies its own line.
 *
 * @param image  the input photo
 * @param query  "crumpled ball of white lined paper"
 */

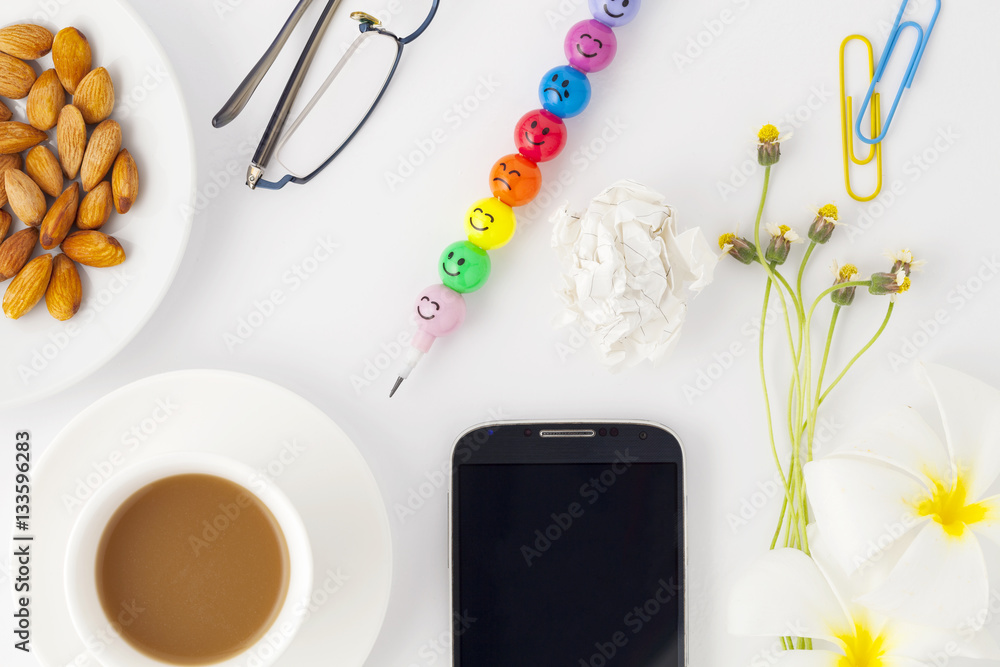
xmin=552 ymin=181 xmax=719 ymax=370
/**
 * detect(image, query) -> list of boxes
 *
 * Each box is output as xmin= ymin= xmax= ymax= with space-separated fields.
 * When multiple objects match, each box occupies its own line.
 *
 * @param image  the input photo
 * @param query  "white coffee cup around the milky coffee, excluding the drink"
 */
xmin=65 ymin=452 xmax=313 ymax=667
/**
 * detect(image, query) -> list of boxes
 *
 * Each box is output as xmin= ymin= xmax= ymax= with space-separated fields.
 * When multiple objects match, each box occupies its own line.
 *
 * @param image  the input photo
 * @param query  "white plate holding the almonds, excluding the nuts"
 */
xmin=0 ymin=0 xmax=195 ymax=408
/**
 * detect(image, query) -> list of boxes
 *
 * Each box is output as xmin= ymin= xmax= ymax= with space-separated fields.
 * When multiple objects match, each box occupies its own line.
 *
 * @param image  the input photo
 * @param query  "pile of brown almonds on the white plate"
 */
xmin=0 ymin=24 xmax=139 ymax=320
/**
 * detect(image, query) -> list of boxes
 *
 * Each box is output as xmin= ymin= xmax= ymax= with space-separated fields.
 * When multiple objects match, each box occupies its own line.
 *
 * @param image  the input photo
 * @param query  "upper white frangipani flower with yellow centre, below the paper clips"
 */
xmin=805 ymin=366 xmax=1000 ymax=628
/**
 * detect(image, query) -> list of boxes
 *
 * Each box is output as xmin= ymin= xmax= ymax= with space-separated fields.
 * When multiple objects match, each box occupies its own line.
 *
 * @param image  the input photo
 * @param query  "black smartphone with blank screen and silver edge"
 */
xmin=450 ymin=422 xmax=686 ymax=667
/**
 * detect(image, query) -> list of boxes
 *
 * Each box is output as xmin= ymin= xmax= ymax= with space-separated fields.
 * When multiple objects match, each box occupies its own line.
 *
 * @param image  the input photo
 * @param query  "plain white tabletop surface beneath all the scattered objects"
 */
xmin=0 ymin=0 xmax=1000 ymax=667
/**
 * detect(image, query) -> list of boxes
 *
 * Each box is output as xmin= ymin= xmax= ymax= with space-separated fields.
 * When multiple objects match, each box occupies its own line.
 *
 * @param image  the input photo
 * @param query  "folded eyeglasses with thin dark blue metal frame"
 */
xmin=212 ymin=0 xmax=440 ymax=190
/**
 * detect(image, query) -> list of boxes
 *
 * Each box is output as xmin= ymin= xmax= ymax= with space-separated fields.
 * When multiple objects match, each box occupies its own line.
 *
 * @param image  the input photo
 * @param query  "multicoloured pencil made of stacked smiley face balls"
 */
xmin=389 ymin=0 xmax=641 ymax=397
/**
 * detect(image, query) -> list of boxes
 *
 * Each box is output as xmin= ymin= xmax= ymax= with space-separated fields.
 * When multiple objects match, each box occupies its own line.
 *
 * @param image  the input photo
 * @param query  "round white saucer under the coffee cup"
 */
xmin=23 ymin=371 xmax=392 ymax=667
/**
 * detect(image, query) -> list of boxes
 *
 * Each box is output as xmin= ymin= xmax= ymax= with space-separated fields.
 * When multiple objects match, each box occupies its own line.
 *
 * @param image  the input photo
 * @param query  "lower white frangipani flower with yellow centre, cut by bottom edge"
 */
xmin=729 ymin=526 xmax=1000 ymax=667
